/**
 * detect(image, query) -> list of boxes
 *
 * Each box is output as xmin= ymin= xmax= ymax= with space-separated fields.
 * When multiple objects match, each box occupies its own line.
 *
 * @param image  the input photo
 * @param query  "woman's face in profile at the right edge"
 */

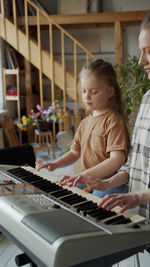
xmin=139 ymin=29 xmax=150 ymax=79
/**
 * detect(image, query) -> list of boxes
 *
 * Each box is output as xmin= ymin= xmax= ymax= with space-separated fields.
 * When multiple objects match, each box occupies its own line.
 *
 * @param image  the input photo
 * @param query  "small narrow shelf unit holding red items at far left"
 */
xmin=3 ymin=68 xmax=21 ymax=121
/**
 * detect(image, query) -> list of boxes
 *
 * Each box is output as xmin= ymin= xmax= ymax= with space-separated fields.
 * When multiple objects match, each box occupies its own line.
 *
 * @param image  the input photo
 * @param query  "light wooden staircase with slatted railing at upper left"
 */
xmin=0 ymin=0 xmax=96 ymax=127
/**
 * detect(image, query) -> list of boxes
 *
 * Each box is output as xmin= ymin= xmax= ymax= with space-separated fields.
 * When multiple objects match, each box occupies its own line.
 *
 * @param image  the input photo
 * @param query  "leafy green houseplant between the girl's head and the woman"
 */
xmin=116 ymin=56 xmax=150 ymax=133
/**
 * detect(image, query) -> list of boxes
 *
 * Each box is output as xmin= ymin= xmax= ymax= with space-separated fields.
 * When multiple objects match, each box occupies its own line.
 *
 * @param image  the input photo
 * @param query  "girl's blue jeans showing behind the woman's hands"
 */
xmin=76 ymin=183 xmax=128 ymax=198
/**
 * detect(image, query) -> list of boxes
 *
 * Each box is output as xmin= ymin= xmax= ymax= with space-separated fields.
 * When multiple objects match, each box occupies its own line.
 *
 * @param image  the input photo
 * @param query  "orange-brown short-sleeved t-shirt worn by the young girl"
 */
xmin=71 ymin=110 xmax=128 ymax=170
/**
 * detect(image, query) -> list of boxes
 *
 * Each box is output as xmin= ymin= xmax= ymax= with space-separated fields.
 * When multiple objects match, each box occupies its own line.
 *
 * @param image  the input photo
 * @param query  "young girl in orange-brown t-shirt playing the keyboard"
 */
xmin=36 ymin=59 xmax=130 ymax=197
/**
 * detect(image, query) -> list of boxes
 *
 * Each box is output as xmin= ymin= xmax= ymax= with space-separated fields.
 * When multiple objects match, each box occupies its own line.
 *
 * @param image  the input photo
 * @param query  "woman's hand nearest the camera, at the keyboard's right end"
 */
xmin=99 ymin=192 xmax=140 ymax=213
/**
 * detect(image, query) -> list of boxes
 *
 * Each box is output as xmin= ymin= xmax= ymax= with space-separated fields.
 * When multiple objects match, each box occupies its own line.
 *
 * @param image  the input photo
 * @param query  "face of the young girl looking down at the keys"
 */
xmin=81 ymin=71 xmax=114 ymax=115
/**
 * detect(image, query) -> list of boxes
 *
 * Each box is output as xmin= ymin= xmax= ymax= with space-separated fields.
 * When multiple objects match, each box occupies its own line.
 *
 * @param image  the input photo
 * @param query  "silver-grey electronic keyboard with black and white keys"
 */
xmin=0 ymin=166 xmax=150 ymax=267
